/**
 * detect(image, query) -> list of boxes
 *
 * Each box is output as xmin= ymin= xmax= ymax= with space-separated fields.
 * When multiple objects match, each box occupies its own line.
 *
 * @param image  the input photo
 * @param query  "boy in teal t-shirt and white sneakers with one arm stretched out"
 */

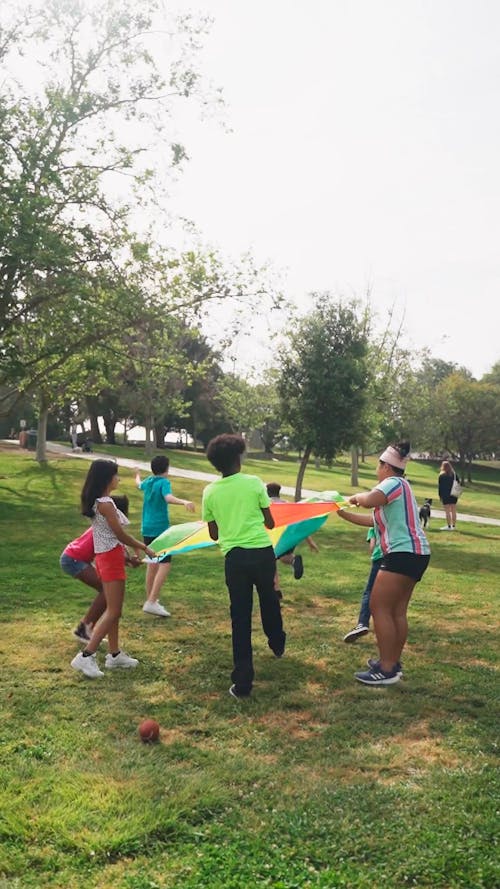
xmin=135 ymin=454 xmax=194 ymax=617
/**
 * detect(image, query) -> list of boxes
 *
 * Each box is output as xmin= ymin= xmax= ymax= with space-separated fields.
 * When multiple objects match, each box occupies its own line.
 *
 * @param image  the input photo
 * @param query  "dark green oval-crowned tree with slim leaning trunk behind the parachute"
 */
xmin=278 ymin=293 xmax=368 ymax=500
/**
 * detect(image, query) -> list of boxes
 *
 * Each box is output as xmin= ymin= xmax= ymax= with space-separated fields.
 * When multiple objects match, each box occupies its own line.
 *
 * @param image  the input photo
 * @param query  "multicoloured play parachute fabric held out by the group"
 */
xmin=150 ymin=491 xmax=347 ymax=561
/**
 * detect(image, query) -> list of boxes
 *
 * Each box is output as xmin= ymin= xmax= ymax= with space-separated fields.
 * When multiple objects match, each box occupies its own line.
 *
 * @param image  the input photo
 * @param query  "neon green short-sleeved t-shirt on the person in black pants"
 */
xmin=201 ymin=472 xmax=271 ymax=555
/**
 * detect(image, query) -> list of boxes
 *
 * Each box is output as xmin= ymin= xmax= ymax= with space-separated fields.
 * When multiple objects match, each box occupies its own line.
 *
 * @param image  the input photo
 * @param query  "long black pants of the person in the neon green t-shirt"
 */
xmin=225 ymin=546 xmax=286 ymax=694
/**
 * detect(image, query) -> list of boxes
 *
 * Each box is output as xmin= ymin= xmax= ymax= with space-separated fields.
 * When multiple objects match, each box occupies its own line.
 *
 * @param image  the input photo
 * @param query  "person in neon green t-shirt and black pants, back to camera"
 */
xmin=202 ymin=434 xmax=286 ymax=698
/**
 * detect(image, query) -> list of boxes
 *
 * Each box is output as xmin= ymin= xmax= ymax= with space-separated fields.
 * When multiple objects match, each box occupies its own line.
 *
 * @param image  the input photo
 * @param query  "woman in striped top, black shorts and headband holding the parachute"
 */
xmin=349 ymin=441 xmax=431 ymax=685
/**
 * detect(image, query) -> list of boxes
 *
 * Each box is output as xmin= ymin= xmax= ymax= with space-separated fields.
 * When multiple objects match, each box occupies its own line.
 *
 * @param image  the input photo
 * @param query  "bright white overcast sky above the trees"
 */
xmin=166 ymin=0 xmax=500 ymax=376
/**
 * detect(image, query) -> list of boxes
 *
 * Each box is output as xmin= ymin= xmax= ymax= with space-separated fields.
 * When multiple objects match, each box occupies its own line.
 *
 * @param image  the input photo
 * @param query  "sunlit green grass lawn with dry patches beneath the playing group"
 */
xmin=0 ymin=449 xmax=500 ymax=889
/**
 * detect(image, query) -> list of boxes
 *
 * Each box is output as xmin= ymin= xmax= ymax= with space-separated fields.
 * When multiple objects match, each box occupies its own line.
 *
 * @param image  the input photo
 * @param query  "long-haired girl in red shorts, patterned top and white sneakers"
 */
xmin=71 ymin=460 xmax=155 ymax=679
